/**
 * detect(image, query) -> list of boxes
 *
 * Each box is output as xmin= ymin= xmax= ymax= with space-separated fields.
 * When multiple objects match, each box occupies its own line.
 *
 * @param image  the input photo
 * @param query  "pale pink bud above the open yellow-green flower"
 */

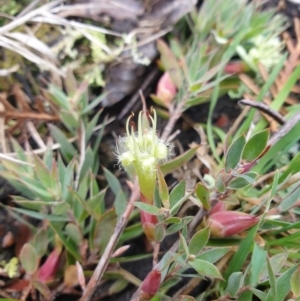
xmin=156 ymin=72 xmax=177 ymax=107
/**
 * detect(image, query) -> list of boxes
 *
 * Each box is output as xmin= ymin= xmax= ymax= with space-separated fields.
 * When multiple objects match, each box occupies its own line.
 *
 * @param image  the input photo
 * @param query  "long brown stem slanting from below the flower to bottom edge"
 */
xmin=80 ymin=181 xmax=140 ymax=301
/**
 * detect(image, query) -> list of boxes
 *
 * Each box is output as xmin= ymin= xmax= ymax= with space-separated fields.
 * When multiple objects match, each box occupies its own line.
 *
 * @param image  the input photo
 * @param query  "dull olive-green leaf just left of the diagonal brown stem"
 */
xmin=93 ymin=208 xmax=117 ymax=254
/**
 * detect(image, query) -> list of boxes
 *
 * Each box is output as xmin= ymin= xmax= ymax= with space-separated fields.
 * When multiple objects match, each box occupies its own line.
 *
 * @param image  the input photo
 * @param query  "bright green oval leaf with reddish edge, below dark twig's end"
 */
xmin=242 ymin=129 xmax=270 ymax=162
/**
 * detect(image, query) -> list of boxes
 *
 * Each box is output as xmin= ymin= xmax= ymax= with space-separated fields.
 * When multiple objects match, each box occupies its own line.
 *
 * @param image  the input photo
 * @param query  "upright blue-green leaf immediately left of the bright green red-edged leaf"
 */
xmin=225 ymin=135 xmax=246 ymax=172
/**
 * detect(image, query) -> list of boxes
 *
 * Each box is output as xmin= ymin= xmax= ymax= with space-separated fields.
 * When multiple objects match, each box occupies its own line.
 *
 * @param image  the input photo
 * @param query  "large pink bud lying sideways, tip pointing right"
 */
xmin=207 ymin=211 xmax=259 ymax=237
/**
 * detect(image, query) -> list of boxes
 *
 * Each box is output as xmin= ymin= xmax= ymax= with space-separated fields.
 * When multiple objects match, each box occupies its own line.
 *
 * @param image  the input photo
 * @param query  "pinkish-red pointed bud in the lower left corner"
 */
xmin=37 ymin=248 xmax=61 ymax=282
